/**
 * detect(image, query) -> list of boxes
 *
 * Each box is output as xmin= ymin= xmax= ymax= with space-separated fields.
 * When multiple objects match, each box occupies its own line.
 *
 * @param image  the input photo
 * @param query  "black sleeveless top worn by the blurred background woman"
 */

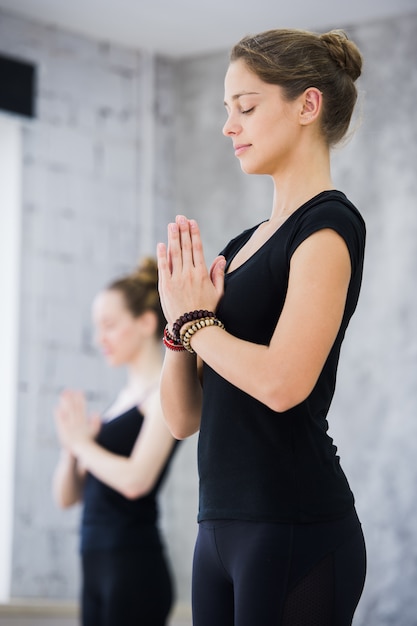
xmin=81 ymin=407 xmax=178 ymax=552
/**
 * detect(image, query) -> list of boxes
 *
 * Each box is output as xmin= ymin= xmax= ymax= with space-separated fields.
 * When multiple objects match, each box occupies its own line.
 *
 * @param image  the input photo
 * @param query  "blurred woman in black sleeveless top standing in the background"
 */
xmin=53 ymin=258 xmax=176 ymax=626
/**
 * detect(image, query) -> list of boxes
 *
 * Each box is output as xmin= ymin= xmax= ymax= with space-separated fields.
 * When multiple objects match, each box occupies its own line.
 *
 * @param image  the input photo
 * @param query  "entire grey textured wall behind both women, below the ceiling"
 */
xmin=0 ymin=6 xmax=417 ymax=626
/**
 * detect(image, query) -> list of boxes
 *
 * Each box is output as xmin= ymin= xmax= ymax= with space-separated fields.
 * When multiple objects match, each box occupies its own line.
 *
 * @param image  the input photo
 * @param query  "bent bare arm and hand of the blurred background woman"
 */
xmin=53 ymin=392 xmax=175 ymax=499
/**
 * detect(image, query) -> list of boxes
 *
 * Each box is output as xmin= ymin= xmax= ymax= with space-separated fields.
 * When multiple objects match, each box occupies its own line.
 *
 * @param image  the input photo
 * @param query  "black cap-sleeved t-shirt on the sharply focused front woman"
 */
xmin=198 ymin=191 xmax=365 ymax=523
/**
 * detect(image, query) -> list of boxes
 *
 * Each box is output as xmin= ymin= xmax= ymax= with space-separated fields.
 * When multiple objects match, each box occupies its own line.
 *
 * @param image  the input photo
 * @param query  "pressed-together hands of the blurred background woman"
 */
xmin=55 ymin=390 xmax=101 ymax=456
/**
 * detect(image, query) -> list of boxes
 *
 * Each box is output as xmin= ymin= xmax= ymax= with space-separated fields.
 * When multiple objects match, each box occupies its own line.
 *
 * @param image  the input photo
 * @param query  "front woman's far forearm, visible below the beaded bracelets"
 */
xmin=160 ymin=350 xmax=202 ymax=439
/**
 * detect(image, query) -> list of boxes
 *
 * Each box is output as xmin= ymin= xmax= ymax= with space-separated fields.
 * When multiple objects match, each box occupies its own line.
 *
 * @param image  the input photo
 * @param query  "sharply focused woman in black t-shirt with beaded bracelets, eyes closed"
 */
xmin=158 ymin=30 xmax=366 ymax=626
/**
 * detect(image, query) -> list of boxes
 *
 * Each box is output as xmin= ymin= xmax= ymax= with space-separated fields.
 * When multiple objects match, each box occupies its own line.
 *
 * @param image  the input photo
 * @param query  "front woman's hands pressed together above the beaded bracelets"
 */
xmin=157 ymin=215 xmax=226 ymax=328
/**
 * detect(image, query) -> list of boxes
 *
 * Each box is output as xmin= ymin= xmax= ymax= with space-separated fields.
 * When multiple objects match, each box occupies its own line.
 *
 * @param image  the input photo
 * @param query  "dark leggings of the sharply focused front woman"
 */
xmin=192 ymin=511 xmax=366 ymax=626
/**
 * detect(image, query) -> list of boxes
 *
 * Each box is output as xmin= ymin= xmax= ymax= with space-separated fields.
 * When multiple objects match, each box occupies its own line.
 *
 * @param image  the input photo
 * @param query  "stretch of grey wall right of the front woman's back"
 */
xmin=334 ymin=14 xmax=417 ymax=626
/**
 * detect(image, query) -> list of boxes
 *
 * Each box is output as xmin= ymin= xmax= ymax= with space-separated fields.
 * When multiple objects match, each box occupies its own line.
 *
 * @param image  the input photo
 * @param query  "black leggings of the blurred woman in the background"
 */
xmin=81 ymin=549 xmax=172 ymax=626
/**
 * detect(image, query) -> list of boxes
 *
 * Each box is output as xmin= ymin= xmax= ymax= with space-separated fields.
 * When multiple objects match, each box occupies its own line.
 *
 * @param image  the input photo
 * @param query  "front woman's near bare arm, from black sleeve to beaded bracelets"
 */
xmin=187 ymin=229 xmax=351 ymax=412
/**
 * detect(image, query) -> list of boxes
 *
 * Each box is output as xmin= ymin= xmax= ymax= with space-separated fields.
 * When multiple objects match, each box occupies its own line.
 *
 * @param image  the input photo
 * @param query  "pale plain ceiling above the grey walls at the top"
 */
xmin=0 ymin=0 xmax=417 ymax=58
